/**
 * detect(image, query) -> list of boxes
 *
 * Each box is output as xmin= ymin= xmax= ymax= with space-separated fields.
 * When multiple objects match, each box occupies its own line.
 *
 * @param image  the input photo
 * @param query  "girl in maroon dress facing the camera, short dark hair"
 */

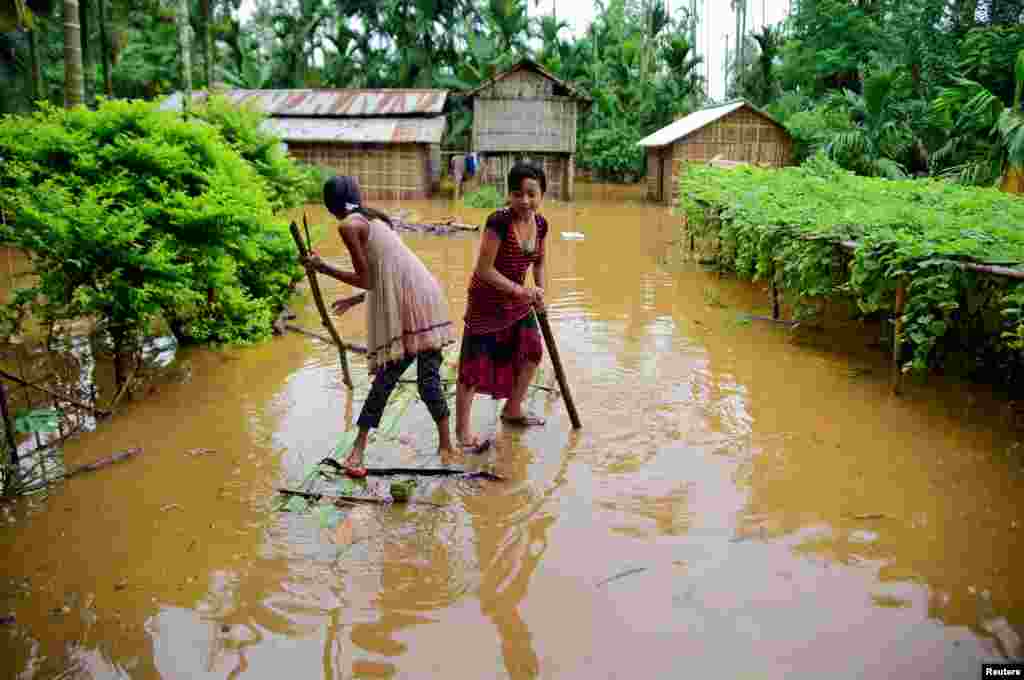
xmin=456 ymin=163 xmax=548 ymax=447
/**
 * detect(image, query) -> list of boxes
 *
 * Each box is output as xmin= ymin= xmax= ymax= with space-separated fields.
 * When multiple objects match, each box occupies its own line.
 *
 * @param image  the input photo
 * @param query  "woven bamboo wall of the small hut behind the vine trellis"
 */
xmin=648 ymin=109 xmax=793 ymax=205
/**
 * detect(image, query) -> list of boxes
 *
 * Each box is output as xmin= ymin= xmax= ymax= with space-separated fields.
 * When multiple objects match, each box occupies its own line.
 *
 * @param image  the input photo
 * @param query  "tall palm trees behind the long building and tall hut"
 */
xmin=0 ymin=0 xmax=705 ymax=178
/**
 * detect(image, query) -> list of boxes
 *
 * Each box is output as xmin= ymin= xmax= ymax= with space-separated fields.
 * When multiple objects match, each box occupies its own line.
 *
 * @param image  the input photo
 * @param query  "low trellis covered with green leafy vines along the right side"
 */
xmin=680 ymin=156 xmax=1024 ymax=370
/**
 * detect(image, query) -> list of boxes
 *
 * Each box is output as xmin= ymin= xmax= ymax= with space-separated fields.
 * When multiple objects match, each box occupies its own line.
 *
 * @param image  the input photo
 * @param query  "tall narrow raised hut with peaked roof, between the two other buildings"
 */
xmin=467 ymin=59 xmax=591 ymax=201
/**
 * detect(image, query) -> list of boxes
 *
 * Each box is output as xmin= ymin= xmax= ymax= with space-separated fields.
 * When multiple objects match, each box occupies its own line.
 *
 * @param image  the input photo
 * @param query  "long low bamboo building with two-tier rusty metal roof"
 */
xmin=162 ymin=89 xmax=447 ymax=201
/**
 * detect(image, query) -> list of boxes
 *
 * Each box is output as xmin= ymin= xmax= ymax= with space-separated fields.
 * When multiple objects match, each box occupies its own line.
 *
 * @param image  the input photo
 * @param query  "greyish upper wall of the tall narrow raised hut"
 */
xmin=473 ymin=71 xmax=577 ymax=154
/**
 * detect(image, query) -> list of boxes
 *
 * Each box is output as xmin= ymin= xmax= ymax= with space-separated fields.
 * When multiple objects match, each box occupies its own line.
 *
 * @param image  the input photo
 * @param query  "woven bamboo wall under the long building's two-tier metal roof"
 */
xmin=288 ymin=142 xmax=430 ymax=201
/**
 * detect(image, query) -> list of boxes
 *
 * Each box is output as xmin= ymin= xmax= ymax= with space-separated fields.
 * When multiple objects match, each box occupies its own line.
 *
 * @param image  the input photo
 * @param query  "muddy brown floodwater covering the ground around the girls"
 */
xmin=0 ymin=189 xmax=1024 ymax=679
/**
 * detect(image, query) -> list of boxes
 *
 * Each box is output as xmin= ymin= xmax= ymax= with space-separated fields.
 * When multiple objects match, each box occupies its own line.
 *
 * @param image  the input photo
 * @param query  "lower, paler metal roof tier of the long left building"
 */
xmin=263 ymin=116 xmax=444 ymax=144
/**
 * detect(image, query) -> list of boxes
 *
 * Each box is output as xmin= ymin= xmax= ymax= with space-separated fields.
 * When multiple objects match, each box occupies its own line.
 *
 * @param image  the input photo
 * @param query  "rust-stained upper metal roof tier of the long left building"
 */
xmin=161 ymin=90 xmax=449 ymax=117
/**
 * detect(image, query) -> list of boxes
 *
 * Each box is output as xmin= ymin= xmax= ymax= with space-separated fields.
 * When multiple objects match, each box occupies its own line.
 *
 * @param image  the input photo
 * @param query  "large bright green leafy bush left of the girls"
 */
xmin=0 ymin=101 xmax=301 ymax=350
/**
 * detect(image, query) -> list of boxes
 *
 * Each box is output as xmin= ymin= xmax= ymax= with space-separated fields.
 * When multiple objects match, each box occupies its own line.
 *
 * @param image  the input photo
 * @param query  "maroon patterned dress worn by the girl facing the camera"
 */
xmin=459 ymin=208 xmax=548 ymax=399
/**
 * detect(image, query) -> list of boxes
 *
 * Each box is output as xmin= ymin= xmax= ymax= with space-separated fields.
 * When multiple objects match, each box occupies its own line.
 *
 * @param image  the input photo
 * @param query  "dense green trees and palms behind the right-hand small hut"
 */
xmin=730 ymin=0 xmax=1024 ymax=186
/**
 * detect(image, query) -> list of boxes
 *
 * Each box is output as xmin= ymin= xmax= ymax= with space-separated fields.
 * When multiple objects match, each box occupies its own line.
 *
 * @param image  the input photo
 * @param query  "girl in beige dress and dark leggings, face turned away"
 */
xmin=303 ymin=177 xmax=473 ymax=477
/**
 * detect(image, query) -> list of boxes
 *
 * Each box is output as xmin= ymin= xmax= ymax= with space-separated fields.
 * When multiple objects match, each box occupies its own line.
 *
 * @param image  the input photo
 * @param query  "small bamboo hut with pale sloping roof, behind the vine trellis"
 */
xmin=637 ymin=101 xmax=793 ymax=205
